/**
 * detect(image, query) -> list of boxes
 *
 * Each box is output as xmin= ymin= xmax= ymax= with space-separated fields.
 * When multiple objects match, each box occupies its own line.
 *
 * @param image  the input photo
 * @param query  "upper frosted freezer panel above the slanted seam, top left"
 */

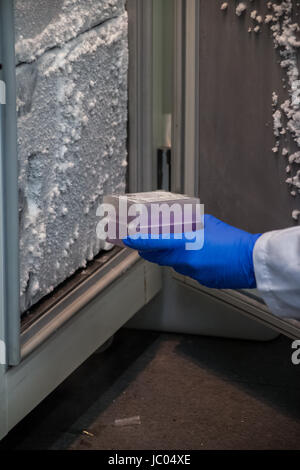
xmin=14 ymin=0 xmax=125 ymax=63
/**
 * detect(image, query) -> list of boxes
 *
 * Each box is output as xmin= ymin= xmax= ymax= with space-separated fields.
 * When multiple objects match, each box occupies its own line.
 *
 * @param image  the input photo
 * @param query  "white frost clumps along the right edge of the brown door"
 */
xmin=220 ymin=0 xmax=300 ymax=220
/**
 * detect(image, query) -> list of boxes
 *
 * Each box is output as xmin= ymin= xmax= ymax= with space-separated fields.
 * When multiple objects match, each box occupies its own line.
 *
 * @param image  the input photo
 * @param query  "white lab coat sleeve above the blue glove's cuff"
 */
xmin=253 ymin=227 xmax=300 ymax=320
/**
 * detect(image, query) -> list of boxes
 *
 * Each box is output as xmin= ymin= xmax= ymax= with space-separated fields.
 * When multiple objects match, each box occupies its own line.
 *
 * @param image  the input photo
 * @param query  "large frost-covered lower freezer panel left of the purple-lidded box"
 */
xmin=16 ymin=6 xmax=128 ymax=312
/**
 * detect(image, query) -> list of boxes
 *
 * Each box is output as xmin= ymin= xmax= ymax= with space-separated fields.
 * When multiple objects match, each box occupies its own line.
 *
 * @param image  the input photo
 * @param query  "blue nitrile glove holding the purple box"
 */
xmin=123 ymin=214 xmax=261 ymax=289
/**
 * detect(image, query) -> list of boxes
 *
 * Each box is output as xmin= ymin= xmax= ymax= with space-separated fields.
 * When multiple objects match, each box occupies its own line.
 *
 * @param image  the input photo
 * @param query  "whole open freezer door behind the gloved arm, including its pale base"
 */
xmin=129 ymin=0 xmax=299 ymax=340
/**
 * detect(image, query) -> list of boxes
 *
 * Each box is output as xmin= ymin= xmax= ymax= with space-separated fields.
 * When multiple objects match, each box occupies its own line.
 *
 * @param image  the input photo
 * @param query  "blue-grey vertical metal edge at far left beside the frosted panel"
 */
xmin=0 ymin=0 xmax=20 ymax=365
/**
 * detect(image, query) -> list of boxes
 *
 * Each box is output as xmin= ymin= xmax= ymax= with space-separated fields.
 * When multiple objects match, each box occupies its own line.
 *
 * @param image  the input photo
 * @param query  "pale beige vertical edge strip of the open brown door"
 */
xmin=172 ymin=0 xmax=200 ymax=196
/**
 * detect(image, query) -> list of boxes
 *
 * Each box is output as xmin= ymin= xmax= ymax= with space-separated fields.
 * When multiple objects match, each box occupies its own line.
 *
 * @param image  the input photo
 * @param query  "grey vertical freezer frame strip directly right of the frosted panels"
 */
xmin=127 ymin=0 xmax=155 ymax=192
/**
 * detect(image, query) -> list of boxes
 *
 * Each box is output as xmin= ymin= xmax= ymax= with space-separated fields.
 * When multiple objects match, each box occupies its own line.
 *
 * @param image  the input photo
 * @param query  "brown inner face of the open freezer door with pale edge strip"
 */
xmin=177 ymin=0 xmax=299 ymax=337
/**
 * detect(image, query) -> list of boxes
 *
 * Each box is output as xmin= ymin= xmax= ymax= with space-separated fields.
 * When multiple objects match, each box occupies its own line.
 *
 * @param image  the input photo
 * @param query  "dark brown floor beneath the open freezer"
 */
xmin=0 ymin=330 xmax=300 ymax=450
